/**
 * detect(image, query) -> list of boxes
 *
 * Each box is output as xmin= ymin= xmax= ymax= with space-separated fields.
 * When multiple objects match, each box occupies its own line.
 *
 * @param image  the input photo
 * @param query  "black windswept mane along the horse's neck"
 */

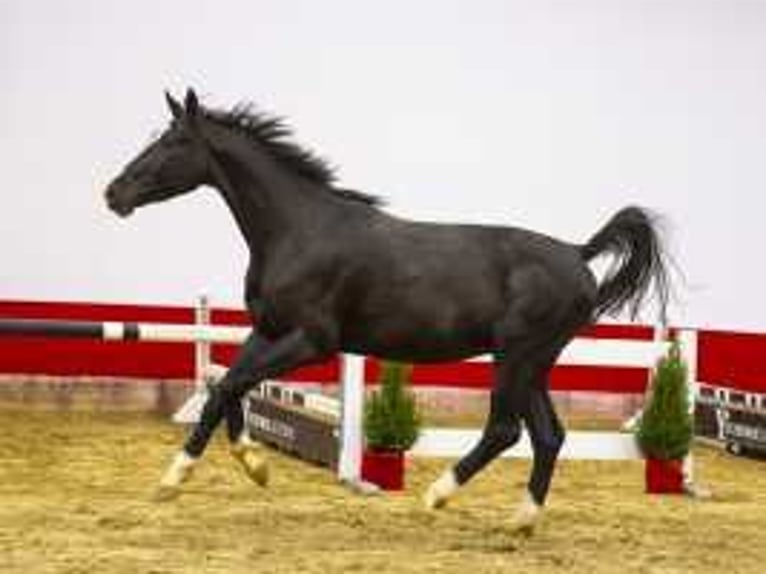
xmin=204 ymin=103 xmax=383 ymax=206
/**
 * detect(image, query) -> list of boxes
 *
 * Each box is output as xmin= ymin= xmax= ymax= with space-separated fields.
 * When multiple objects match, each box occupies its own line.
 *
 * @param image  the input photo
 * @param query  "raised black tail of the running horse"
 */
xmin=580 ymin=207 xmax=670 ymax=324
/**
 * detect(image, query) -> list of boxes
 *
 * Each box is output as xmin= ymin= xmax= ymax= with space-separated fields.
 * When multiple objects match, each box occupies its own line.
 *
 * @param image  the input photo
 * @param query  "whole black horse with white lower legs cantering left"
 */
xmin=106 ymin=90 xmax=669 ymax=527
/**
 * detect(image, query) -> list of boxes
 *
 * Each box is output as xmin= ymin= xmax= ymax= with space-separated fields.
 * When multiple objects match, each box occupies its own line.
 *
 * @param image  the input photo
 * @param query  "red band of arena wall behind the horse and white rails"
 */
xmin=0 ymin=300 xmax=766 ymax=393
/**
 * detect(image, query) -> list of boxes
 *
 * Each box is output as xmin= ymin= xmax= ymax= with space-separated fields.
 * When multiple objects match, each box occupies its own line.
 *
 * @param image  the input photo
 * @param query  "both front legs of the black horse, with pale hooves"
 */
xmin=155 ymin=329 xmax=320 ymax=500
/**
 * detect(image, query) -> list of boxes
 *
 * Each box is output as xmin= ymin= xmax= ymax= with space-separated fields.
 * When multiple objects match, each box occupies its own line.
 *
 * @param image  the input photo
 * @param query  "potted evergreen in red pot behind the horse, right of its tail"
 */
xmin=637 ymin=341 xmax=694 ymax=494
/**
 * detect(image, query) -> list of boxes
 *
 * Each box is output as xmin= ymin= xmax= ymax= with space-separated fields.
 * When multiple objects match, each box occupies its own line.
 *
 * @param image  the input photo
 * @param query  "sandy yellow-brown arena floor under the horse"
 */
xmin=0 ymin=411 xmax=766 ymax=574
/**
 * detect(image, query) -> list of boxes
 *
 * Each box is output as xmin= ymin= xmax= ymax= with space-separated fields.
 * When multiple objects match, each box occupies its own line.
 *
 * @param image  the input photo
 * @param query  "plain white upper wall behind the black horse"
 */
xmin=0 ymin=0 xmax=766 ymax=331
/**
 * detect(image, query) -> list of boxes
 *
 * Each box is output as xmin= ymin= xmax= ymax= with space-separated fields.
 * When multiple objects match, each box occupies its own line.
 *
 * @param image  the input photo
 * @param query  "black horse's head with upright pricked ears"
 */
xmin=106 ymin=90 xmax=209 ymax=217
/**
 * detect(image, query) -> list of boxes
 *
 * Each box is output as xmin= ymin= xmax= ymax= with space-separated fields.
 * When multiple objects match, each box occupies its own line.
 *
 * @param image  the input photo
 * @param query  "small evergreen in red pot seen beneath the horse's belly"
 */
xmin=362 ymin=361 xmax=421 ymax=490
